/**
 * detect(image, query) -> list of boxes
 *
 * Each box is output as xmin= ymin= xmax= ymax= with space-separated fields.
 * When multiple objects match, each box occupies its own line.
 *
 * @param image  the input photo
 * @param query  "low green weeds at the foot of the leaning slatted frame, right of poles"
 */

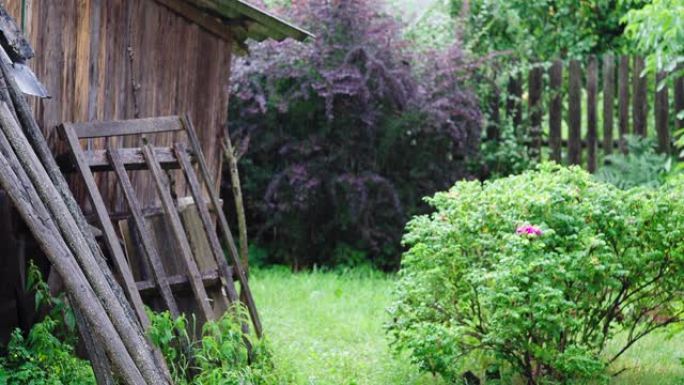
xmin=149 ymin=311 xmax=287 ymax=385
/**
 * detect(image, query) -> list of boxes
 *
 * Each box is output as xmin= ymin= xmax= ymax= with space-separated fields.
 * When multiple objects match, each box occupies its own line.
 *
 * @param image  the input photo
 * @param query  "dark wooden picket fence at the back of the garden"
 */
xmin=487 ymin=55 xmax=684 ymax=172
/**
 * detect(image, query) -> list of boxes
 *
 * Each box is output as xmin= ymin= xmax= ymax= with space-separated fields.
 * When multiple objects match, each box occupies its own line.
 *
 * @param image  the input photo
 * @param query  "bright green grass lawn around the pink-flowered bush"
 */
xmin=251 ymin=269 xmax=684 ymax=385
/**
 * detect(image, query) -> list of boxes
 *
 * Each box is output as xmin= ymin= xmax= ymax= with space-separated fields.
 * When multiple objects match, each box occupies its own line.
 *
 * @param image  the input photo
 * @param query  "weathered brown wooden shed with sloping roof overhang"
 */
xmin=0 ymin=0 xmax=309 ymax=343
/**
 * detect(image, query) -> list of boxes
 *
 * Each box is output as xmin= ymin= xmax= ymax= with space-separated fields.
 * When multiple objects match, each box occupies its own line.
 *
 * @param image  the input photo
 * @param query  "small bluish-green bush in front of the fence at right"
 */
xmin=596 ymin=135 xmax=672 ymax=189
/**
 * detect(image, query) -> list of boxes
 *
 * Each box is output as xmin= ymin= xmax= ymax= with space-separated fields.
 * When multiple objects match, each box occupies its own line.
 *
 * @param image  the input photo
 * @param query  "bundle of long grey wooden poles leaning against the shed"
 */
xmin=0 ymin=51 xmax=172 ymax=385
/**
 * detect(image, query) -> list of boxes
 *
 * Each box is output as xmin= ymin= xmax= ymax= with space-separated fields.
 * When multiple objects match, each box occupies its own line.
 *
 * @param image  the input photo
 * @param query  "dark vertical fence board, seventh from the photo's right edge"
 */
xmin=568 ymin=60 xmax=582 ymax=164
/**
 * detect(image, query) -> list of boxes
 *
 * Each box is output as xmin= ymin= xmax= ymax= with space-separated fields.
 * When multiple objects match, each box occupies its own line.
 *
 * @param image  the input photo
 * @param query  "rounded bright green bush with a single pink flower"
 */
xmin=388 ymin=164 xmax=684 ymax=384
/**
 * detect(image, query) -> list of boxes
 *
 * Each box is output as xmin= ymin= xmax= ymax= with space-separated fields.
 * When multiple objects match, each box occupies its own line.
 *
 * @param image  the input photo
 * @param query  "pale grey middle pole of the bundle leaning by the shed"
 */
xmin=0 ymin=103 xmax=168 ymax=385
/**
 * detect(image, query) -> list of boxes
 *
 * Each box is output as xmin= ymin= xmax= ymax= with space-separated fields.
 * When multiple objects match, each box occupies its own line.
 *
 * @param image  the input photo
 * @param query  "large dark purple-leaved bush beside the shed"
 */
xmin=224 ymin=0 xmax=480 ymax=268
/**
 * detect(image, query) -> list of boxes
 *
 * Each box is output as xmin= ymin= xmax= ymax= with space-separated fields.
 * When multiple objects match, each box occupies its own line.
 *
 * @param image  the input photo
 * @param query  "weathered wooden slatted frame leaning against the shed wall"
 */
xmin=59 ymin=116 xmax=262 ymax=338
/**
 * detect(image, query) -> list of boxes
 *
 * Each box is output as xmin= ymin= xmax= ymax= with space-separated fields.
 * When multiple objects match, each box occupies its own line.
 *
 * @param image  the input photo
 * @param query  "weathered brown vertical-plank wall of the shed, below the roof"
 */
xmin=0 ymin=0 xmax=232 ymax=211
